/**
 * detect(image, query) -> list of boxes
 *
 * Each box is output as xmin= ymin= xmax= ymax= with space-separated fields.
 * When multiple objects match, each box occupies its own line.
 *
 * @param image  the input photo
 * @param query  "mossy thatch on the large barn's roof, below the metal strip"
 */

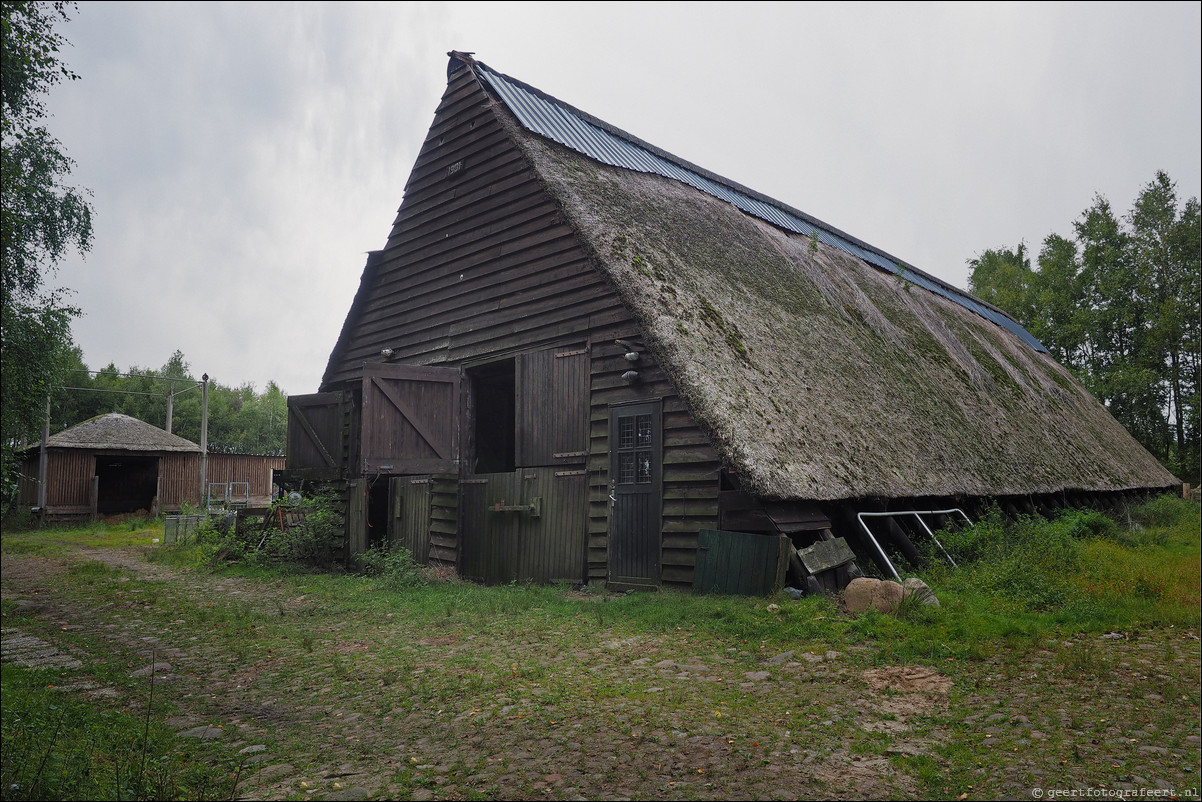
xmin=473 ymin=59 xmax=1177 ymax=500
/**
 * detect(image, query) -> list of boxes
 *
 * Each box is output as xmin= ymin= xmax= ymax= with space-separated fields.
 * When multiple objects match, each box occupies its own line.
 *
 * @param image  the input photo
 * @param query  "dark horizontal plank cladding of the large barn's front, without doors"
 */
xmin=322 ymin=62 xmax=720 ymax=587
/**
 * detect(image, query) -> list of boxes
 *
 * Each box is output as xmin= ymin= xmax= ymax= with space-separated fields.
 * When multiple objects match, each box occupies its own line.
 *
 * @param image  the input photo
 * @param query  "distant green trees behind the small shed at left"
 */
xmin=50 ymin=349 xmax=288 ymax=456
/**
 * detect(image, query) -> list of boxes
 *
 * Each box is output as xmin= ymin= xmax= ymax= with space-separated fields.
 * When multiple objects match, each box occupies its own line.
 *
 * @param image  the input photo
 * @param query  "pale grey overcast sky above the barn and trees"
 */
xmin=39 ymin=1 xmax=1202 ymax=393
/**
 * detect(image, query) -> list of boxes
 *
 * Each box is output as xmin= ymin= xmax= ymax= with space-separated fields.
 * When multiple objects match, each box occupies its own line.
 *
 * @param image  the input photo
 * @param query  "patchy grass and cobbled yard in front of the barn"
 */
xmin=2 ymin=498 xmax=1200 ymax=800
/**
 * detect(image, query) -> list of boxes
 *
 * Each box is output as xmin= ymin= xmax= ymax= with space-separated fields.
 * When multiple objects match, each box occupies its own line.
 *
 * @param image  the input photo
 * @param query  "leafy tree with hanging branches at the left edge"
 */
xmin=0 ymin=1 xmax=91 ymax=504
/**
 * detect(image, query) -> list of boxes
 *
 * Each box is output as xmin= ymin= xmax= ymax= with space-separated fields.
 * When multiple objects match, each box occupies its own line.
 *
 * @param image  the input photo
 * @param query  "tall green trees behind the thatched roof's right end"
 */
xmin=969 ymin=172 xmax=1202 ymax=483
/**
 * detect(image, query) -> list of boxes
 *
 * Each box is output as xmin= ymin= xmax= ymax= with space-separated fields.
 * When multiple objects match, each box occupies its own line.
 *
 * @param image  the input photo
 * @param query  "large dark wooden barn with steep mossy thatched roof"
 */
xmin=284 ymin=53 xmax=1177 ymax=592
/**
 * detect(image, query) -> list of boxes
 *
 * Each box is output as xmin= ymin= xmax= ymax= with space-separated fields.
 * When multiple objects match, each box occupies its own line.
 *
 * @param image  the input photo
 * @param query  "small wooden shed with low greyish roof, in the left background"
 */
xmin=17 ymin=412 xmax=284 ymax=521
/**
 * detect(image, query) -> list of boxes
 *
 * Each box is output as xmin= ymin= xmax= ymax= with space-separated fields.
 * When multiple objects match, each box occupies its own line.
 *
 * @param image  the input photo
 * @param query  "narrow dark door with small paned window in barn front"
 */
xmin=609 ymin=402 xmax=664 ymax=586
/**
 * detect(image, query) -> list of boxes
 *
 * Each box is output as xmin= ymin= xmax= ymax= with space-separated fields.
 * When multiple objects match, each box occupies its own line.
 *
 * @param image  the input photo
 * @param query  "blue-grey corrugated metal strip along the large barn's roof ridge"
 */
xmin=474 ymin=61 xmax=1047 ymax=352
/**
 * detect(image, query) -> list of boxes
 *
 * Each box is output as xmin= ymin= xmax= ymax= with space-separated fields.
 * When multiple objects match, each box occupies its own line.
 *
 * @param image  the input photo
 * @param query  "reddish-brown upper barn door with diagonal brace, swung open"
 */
xmin=359 ymin=364 xmax=459 ymax=476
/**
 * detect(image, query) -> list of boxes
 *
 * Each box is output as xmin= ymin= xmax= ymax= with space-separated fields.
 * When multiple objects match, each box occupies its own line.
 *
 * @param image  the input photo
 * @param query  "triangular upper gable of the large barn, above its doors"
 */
xmin=323 ymin=62 xmax=627 ymax=388
